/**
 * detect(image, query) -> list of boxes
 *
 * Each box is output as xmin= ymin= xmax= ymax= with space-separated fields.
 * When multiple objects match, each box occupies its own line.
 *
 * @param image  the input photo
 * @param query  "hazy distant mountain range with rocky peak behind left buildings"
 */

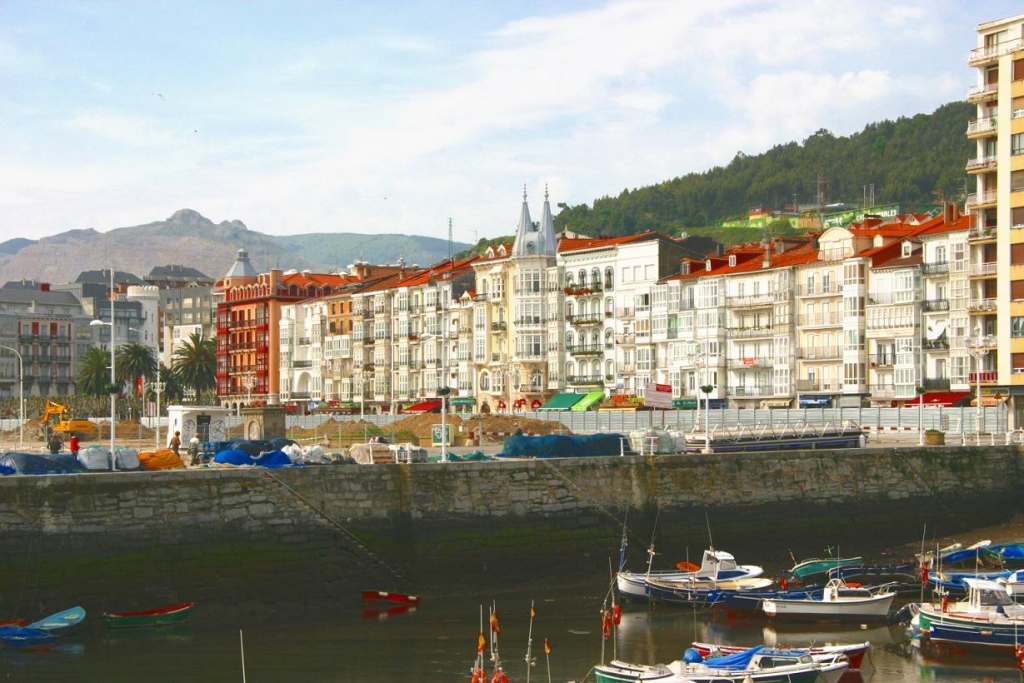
xmin=0 ymin=209 xmax=468 ymax=284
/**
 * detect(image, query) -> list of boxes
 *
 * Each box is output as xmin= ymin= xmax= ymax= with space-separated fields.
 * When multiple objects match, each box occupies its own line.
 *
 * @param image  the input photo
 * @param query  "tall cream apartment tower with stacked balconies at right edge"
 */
xmin=954 ymin=14 xmax=1024 ymax=427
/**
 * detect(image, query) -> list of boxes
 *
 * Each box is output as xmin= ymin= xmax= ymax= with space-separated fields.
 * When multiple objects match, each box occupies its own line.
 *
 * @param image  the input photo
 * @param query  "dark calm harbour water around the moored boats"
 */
xmin=0 ymin=594 xmax=1024 ymax=683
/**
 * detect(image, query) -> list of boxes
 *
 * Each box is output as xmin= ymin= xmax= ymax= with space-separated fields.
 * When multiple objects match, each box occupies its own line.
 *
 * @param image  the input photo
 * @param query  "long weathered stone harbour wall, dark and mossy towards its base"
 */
xmin=0 ymin=447 xmax=1021 ymax=616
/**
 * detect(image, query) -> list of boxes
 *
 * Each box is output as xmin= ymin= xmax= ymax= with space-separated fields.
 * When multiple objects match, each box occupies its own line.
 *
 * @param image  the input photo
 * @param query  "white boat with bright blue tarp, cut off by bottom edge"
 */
xmin=594 ymin=645 xmax=850 ymax=683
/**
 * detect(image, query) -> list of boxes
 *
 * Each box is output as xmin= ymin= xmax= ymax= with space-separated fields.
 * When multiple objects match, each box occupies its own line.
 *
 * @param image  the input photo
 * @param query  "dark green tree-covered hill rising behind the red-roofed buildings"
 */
xmin=555 ymin=102 xmax=975 ymax=237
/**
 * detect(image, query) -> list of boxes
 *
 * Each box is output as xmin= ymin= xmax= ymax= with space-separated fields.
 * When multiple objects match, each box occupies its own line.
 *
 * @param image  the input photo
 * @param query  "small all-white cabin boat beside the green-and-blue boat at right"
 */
xmin=761 ymin=579 xmax=896 ymax=620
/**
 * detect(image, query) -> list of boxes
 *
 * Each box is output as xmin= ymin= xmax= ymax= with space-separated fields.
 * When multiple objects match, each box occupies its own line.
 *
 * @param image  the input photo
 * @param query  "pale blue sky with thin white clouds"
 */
xmin=0 ymin=0 xmax=1024 ymax=243
